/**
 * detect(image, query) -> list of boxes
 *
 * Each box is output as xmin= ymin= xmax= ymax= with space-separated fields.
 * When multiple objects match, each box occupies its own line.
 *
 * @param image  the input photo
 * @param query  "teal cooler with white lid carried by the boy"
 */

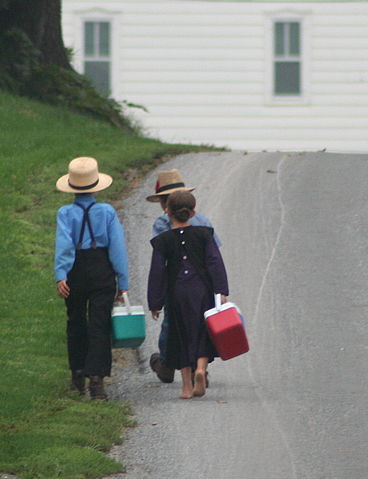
xmin=111 ymin=294 xmax=146 ymax=348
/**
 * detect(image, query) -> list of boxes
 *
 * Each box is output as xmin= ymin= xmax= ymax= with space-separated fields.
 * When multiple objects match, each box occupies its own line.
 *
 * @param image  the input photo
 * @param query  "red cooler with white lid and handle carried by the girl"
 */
xmin=204 ymin=294 xmax=249 ymax=361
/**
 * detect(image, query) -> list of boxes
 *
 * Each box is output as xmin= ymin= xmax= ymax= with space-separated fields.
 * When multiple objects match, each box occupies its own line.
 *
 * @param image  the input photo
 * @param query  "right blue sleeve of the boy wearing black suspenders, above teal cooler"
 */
xmin=108 ymin=210 xmax=129 ymax=289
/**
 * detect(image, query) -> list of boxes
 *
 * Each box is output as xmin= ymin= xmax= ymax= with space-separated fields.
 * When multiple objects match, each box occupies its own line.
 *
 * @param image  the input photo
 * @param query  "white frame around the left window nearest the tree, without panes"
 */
xmin=73 ymin=8 xmax=121 ymax=98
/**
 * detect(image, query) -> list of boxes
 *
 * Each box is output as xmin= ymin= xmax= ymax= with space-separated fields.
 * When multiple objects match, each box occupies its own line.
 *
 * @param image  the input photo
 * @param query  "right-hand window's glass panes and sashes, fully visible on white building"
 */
xmin=273 ymin=21 xmax=302 ymax=96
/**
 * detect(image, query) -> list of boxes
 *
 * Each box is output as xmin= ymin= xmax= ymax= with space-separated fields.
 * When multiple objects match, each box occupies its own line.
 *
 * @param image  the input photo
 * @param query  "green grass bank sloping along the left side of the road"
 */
xmin=0 ymin=92 xmax=218 ymax=479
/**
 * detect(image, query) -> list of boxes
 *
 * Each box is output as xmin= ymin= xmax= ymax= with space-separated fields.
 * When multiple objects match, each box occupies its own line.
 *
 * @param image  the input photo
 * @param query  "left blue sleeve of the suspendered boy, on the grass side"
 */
xmin=54 ymin=207 xmax=75 ymax=282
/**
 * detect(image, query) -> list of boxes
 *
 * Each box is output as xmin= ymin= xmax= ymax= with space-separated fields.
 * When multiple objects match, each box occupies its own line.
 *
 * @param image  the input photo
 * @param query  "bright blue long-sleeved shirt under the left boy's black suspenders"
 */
xmin=55 ymin=194 xmax=128 ymax=290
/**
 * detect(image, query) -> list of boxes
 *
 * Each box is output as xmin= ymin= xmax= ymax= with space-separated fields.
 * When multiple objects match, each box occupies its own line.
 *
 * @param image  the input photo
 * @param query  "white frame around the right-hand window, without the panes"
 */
xmin=264 ymin=11 xmax=310 ymax=106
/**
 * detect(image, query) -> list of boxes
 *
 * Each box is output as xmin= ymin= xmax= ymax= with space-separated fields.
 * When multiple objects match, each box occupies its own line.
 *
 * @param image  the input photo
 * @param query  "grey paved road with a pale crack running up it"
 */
xmin=105 ymin=152 xmax=368 ymax=479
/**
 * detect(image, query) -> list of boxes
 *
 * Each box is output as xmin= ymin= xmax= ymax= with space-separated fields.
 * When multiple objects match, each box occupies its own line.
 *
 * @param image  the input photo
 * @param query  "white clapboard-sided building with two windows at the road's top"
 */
xmin=63 ymin=0 xmax=368 ymax=152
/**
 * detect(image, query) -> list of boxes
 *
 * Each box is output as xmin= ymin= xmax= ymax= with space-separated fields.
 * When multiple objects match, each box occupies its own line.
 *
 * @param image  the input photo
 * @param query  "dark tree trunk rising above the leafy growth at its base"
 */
xmin=0 ymin=0 xmax=71 ymax=69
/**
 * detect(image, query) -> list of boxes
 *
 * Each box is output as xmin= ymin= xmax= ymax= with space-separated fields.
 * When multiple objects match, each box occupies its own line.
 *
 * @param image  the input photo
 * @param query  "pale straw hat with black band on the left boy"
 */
xmin=56 ymin=157 xmax=112 ymax=193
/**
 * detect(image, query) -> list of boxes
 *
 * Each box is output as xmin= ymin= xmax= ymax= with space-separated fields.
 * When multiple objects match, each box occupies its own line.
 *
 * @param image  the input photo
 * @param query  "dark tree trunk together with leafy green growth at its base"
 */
xmin=0 ymin=0 xmax=134 ymax=133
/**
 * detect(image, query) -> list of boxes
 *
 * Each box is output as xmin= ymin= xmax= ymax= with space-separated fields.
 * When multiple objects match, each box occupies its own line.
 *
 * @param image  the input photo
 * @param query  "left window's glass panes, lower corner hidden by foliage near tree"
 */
xmin=83 ymin=21 xmax=111 ymax=95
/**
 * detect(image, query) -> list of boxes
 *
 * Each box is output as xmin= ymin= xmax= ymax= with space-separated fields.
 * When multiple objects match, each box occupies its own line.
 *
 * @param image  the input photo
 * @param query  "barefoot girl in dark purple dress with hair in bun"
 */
xmin=148 ymin=190 xmax=229 ymax=399
